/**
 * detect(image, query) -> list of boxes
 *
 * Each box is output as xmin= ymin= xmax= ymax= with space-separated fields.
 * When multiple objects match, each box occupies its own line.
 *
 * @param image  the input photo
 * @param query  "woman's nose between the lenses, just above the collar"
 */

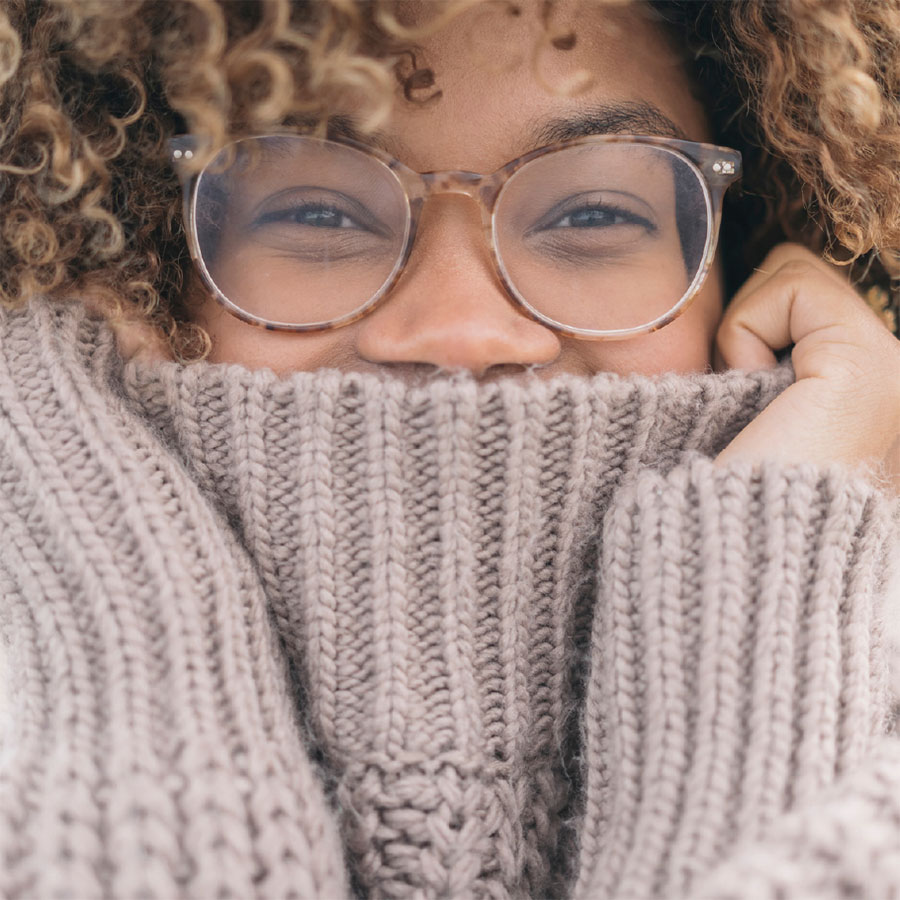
xmin=357 ymin=194 xmax=561 ymax=377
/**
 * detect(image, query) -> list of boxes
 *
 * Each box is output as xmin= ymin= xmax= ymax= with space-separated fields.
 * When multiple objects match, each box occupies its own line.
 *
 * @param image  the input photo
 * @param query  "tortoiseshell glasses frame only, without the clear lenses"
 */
xmin=169 ymin=132 xmax=741 ymax=340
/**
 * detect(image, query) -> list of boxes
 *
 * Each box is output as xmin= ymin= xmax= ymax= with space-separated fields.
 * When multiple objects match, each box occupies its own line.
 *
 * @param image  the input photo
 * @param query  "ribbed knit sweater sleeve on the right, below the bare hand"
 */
xmin=575 ymin=455 xmax=900 ymax=900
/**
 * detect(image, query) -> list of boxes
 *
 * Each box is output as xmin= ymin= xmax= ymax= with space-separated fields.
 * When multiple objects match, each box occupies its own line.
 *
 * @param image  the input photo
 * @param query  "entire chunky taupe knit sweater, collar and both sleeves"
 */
xmin=0 ymin=300 xmax=900 ymax=900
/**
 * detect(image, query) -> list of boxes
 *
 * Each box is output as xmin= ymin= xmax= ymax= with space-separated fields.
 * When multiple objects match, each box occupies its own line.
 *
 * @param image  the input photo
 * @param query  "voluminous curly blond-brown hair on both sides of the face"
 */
xmin=0 ymin=0 xmax=900 ymax=361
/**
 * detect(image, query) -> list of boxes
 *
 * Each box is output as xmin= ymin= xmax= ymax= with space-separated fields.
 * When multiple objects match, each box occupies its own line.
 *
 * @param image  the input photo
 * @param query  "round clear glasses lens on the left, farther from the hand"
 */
xmin=194 ymin=135 xmax=409 ymax=325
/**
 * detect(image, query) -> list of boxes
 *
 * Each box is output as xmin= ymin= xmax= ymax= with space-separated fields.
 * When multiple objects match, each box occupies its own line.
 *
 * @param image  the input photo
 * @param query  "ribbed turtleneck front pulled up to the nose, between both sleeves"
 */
xmin=123 ymin=348 xmax=792 ymax=896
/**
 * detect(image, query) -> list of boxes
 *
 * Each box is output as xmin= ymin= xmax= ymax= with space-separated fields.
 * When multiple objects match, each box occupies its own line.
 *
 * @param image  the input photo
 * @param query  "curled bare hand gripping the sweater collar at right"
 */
xmin=715 ymin=244 xmax=900 ymax=494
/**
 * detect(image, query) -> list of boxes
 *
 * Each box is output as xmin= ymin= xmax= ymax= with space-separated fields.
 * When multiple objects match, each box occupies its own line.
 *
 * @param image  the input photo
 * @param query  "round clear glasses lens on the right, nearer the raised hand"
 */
xmin=494 ymin=143 xmax=710 ymax=331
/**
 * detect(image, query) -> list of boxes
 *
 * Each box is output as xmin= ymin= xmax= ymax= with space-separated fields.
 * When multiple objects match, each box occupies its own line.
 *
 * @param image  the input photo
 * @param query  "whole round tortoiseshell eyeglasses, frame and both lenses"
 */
xmin=170 ymin=134 xmax=741 ymax=340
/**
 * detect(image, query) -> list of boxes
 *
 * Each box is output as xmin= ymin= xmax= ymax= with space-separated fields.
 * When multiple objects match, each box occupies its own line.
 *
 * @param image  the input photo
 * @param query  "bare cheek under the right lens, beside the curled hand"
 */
xmin=566 ymin=272 xmax=722 ymax=375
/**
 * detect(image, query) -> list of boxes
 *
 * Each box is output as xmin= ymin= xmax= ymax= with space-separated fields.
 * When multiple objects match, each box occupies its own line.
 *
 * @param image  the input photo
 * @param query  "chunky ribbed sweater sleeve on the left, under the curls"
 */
xmin=0 ymin=303 xmax=347 ymax=900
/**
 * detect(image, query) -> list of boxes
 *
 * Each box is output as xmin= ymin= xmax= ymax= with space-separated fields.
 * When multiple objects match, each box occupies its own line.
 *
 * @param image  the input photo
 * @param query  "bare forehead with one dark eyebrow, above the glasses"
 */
xmin=338 ymin=0 xmax=711 ymax=171
